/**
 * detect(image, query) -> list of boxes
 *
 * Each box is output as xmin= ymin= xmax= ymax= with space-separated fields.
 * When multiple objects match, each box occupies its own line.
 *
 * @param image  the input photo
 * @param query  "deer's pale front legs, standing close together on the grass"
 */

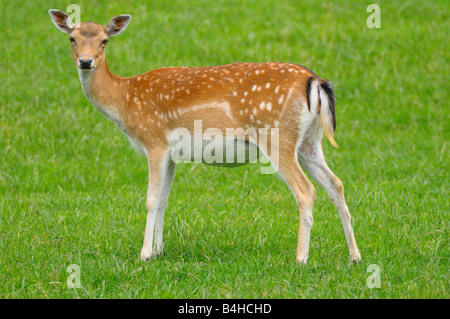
xmin=141 ymin=149 xmax=175 ymax=261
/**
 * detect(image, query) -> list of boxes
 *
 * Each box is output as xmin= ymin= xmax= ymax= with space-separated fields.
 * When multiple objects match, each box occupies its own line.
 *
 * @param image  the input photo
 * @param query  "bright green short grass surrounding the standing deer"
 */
xmin=0 ymin=0 xmax=450 ymax=298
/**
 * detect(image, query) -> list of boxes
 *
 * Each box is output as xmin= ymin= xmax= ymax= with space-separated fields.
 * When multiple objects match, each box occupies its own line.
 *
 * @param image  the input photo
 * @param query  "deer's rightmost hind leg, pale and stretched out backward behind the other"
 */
xmin=298 ymin=138 xmax=361 ymax=263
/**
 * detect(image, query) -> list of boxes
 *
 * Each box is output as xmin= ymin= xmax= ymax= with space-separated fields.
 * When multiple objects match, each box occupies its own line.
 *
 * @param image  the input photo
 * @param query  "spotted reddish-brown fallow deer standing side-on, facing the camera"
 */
xmin=49 ymin=9 xmax=361 ymax=263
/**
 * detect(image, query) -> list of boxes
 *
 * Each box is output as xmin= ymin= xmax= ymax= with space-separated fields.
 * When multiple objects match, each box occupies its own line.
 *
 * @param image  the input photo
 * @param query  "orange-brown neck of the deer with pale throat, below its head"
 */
xmin=78 ymin=61 xmax=129 ymax=130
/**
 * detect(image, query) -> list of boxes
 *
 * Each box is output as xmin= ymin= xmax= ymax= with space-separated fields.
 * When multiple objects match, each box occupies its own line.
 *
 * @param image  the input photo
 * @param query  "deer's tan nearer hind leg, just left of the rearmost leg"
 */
xmin=260 ymin=136 xmax=316 ymax=264
